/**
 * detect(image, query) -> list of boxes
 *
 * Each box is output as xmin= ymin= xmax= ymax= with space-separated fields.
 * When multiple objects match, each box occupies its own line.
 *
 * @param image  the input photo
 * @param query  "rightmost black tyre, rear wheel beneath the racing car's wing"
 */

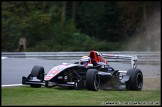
xmin=126 ymin=69 xmax=143 ymax=90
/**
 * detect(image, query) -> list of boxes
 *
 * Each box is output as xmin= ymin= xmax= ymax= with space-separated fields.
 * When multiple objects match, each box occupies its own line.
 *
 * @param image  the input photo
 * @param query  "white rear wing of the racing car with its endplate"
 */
xmin=102 ymin=54 xmax=137 ymax=68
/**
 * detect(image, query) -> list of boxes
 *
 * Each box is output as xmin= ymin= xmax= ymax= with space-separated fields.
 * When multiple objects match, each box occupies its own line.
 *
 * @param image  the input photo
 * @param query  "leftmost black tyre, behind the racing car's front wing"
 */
xmin=31 ymin=65 xmax=44 ymax=81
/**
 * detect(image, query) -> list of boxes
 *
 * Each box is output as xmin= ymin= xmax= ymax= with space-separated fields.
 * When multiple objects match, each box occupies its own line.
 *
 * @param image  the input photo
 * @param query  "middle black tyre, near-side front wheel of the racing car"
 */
xmin=86 ymin=69 xmax=100 ymax=91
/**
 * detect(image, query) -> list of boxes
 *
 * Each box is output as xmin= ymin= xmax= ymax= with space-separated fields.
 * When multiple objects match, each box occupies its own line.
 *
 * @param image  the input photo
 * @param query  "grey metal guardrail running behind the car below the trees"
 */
xmin=1 ymin=51 xmax=161 ymax=62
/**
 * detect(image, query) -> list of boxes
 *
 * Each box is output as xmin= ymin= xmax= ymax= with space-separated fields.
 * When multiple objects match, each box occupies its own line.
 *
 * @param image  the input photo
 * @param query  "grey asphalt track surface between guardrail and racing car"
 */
xmin=1 ymin=58 xmax=161 ymax=85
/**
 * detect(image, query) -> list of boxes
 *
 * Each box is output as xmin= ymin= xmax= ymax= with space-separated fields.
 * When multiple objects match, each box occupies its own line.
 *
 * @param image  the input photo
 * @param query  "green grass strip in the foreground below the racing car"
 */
xmin=1 ymin=86 xmax=161 ymax=106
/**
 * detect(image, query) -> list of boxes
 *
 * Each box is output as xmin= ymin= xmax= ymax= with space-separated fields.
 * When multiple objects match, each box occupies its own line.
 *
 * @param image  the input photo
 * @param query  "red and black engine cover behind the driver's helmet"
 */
xmin=88 ymin=50 xmax=108 ymax=64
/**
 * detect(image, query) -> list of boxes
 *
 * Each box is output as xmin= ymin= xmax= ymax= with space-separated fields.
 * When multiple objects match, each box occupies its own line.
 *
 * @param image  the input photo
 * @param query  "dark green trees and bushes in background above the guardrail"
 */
xmin=1 ymin=1 xmax=161 ymax=51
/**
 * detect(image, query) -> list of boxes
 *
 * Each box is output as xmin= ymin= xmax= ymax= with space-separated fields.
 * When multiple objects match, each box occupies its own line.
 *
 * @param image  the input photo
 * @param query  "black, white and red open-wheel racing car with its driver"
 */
xmin=22 ymin=50 xmax=143 ymax=91
